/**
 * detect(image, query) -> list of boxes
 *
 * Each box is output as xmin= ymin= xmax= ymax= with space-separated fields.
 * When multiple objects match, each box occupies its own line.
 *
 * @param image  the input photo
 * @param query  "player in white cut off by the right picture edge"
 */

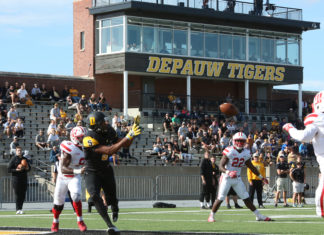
xmin=282 ymin=91 xmax=324 ymax=218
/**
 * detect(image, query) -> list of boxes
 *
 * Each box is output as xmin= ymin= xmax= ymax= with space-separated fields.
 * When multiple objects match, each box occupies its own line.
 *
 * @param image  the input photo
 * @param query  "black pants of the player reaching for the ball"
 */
xmin=85 ymin=165 xmax=118 ymax=227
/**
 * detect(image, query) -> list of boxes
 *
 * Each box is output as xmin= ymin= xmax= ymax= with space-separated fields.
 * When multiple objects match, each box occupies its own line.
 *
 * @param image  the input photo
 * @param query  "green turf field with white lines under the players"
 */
xmin=0 ymin=206 xmax=324 ymax=234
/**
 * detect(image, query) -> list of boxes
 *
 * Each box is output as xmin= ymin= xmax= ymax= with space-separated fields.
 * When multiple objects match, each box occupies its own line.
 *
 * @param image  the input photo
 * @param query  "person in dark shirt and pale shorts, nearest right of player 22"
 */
xmin=275 ymin=155 xmax=290 ymax=207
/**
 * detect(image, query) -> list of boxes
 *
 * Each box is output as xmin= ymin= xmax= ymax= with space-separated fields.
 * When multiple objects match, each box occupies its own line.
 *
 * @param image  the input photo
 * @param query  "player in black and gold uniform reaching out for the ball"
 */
xmin=83 ymin=112 xmax=141 ymax=234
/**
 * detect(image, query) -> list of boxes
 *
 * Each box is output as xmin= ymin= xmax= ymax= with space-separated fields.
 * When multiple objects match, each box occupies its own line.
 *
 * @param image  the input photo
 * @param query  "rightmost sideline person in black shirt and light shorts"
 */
xmin=290 ymin=162 xmax=306 ymax=207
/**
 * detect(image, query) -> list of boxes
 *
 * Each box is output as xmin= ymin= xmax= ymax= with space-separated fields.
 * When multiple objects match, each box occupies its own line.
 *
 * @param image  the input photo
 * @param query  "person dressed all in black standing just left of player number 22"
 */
xmin=199 ymin=151 xmax=218 ymax=209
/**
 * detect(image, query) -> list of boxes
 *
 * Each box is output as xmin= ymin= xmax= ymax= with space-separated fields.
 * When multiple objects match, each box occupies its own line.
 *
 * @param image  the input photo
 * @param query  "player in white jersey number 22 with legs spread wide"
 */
xmin=208 ymin=132 xmax=272 ymax=222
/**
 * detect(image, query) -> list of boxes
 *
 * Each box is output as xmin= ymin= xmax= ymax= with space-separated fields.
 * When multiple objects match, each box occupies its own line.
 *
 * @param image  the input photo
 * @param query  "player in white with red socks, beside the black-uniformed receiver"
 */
xmin=51 ymin=126 xmax=87 ymax=232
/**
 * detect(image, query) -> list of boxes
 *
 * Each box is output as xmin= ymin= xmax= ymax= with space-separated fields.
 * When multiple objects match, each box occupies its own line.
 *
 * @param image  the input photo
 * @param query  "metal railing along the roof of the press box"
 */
xmin=92 ymin=0 xmax=302 ymax=20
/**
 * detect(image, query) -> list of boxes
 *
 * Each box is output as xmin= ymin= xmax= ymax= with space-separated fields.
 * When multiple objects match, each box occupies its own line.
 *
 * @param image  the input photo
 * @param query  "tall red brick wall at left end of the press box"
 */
xmin=73 ymin=0 xmax=95 ymax=77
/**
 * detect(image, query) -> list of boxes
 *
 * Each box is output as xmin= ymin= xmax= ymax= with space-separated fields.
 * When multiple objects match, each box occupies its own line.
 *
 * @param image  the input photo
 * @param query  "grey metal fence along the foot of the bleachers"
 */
xmin=0 ymin=175 xmax=318 ymax=205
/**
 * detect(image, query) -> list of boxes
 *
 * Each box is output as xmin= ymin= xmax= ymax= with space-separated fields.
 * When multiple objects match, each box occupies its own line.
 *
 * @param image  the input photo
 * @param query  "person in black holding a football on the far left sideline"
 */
xmin=8 ymin=146 xmax=30 ymax=215
